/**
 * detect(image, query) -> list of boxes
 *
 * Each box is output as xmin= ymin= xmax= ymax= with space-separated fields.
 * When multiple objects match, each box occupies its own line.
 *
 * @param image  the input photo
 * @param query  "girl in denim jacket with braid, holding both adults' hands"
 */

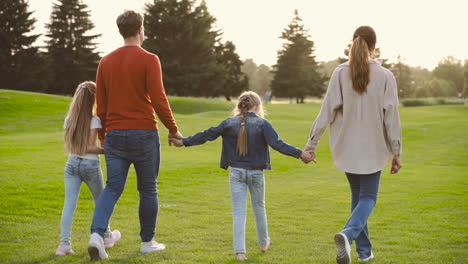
xmin=171 ymin=91 xmax=313 ymax=261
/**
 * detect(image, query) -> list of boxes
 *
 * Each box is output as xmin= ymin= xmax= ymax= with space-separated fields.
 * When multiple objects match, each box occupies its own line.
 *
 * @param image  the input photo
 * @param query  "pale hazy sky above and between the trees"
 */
xmin=29 ymin=0 xmax=468 ymax=69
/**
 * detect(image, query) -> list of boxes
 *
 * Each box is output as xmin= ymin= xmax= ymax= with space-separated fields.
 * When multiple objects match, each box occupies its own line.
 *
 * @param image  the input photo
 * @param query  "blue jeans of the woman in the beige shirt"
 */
xmin=342 ymin=171 xmax=381 ymax=258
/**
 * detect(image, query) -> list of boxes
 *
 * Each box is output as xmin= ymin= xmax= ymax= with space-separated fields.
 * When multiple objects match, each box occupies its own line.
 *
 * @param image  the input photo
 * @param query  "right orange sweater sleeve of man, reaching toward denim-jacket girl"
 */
xmin=146 ymin=55 xmax=179 ymax=134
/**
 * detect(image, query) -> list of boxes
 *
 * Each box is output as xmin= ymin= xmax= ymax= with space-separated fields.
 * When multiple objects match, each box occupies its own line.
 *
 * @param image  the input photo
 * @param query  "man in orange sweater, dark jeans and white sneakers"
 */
xmin=88 ymin=11 xmax=182 ymax=260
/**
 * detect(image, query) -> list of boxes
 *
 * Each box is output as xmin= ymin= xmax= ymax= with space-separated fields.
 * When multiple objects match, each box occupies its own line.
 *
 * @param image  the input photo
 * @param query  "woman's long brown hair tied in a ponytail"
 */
xmin=349 ymin=26 xmax=377 ymax=94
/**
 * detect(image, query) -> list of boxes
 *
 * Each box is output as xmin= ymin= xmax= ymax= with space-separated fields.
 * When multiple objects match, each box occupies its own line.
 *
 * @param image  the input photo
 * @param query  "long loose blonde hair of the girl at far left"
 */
xmin=64 ymin=81 xmax=96 ymax=155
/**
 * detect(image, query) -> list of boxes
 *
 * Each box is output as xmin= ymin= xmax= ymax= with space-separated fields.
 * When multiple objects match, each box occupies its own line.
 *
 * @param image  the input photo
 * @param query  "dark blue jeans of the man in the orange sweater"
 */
xmin=91 ymin=129 xmax=160 ymax=242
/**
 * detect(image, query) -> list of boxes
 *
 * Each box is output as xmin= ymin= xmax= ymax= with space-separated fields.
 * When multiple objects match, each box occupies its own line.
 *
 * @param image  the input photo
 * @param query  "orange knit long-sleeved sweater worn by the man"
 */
xmin=96 ymin=46 xmax=178 ymax=141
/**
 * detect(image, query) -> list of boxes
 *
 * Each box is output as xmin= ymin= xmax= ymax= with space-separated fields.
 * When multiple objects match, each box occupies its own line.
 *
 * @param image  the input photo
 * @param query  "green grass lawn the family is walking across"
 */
xmin=0 ymin=90 xmax=468 ymax=264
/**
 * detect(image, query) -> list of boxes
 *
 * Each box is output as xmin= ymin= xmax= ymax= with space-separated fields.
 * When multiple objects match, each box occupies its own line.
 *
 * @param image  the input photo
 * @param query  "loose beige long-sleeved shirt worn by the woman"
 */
xmin=306 ymin=61 xmax=402 ymax=174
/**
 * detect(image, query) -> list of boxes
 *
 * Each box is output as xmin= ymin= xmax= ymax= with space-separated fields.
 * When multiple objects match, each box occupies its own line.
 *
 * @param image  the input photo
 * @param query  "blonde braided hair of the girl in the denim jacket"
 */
xmin=233 ymin=91 xmax=265 ymax=156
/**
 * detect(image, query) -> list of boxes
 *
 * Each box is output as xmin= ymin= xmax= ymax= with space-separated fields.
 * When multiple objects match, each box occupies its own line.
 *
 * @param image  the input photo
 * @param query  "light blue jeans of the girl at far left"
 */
xmin=60 ymin=156 xmax=110 ymax=245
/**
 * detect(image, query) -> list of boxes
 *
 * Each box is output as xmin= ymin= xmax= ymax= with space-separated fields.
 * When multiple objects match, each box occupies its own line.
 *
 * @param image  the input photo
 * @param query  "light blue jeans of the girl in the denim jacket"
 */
xmin=229 ymin=168 xmax=268 ymax=253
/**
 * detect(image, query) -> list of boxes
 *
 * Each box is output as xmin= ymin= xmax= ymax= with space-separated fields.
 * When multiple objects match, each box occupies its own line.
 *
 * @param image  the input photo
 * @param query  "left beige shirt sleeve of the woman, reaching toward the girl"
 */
xmin=306 ymin=68 xmax=343 ymax=149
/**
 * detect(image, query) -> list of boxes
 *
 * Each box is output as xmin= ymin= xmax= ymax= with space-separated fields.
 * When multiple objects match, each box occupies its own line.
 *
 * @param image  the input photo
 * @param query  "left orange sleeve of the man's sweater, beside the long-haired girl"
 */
xmin=96 ymin=61 xmax=108 ymax=146
